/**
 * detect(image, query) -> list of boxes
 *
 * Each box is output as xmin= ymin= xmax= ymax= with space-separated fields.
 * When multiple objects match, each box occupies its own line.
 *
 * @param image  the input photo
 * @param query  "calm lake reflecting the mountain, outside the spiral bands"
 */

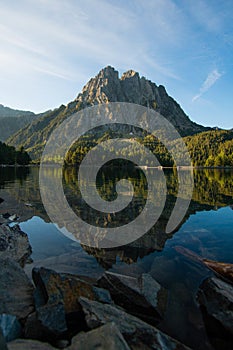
xmin=0 ymin=166 xmax=233 ymax=350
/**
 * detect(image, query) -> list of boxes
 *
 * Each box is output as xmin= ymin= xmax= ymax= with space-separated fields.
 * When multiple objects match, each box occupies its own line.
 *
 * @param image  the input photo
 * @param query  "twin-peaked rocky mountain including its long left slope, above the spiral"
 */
xmin=7 ymin=66 xmax=210 ymax=160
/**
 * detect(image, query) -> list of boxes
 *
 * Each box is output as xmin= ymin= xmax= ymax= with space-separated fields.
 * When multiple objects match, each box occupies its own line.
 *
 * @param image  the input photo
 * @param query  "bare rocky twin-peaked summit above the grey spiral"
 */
xmin=76 ymin=66 xmax=207 ymax=135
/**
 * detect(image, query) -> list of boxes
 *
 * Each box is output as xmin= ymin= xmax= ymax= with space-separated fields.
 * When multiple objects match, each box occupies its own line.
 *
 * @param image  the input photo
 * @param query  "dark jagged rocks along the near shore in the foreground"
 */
xmin=0 ymin=201 xmax=233 ymax=350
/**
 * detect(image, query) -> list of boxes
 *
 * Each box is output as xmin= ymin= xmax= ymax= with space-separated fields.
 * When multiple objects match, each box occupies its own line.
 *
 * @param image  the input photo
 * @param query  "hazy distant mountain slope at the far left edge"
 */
xmin=0 ymin=104 xmax=48 ymax=141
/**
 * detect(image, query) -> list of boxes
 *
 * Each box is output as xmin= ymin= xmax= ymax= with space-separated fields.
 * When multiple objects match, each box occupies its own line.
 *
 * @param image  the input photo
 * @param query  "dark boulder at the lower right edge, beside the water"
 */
xmin=198 ymin=277 xmax=233 ymax=349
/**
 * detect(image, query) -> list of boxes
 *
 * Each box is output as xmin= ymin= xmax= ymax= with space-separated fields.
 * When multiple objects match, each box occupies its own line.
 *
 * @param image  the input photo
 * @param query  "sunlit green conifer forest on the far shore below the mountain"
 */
xmin=65 ymin=130 xmax=233 ymax=167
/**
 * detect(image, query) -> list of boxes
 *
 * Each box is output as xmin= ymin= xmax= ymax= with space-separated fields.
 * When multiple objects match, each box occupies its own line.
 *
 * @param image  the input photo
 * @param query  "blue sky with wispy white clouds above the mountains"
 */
xmin=0 ymin=0 xmax=233 ymax=128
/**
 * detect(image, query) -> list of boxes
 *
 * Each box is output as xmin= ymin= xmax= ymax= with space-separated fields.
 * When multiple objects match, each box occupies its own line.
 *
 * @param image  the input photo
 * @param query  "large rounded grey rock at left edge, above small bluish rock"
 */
xmin=0 ymin=258 xmax=34 ymax=319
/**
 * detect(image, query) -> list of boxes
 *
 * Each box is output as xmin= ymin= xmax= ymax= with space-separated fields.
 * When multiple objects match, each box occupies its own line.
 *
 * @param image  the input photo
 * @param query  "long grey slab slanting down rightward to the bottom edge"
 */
xmin=79 ymin=297 xmax=189 ymax=350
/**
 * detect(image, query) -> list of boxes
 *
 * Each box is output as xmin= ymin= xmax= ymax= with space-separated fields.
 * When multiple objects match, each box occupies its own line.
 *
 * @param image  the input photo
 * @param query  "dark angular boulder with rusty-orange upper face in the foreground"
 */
xmin=25 ymin=268 xmax=112 ymax=344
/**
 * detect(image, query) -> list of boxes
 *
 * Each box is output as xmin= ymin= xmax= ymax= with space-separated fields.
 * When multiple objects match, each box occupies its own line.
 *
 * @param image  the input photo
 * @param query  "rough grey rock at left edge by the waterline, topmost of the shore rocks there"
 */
xmin=0 ymin=225 xmax=32 ymax=266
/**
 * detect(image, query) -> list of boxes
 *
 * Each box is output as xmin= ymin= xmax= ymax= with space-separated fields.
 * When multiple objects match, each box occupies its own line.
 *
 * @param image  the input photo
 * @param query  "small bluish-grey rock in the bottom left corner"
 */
xmin=0 ymin=314 xmax=22 ymax=342
